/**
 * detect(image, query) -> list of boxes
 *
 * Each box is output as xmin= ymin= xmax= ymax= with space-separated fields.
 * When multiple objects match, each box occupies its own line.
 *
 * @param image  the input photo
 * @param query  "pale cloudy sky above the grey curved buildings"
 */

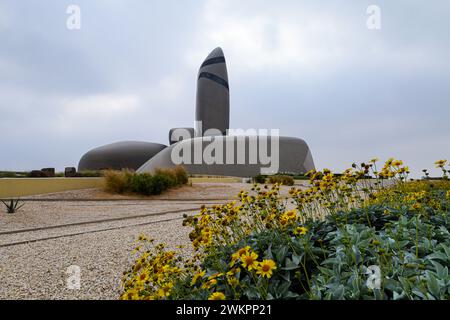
xmin=0 ymin=0 xmax=450 ymax=173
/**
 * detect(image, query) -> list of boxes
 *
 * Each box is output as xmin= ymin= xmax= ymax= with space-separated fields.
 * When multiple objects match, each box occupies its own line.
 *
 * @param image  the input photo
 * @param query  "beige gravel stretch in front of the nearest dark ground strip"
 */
xmin=0 ymin=220 xmax=189 ymax=299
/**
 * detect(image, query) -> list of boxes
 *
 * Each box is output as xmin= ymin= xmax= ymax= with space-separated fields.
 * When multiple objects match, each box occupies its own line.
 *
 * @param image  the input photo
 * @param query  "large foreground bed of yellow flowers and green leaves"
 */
xmin=121 ymin=159 xmax=450 ymax=300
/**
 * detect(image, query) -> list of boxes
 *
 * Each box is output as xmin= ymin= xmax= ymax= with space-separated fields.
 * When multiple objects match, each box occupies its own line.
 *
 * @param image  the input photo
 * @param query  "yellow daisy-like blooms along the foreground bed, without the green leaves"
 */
xmin=121 ymin=158 xmax=450 ymax=300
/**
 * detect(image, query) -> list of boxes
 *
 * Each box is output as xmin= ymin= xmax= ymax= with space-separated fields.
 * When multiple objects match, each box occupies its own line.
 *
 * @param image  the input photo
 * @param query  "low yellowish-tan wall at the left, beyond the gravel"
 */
xmin=0 ymin=178 xmax=103 ymax=198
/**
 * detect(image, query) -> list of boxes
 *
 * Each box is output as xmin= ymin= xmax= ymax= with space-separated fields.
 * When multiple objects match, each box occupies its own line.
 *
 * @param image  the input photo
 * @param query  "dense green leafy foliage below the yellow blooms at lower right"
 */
xmin=206 ymin=207 xmax=450 ymax=300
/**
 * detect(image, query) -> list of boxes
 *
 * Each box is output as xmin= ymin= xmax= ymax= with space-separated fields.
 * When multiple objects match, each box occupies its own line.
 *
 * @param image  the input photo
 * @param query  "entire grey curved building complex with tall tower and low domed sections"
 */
xmin=78 ymin=48 xmax=314 ymax=177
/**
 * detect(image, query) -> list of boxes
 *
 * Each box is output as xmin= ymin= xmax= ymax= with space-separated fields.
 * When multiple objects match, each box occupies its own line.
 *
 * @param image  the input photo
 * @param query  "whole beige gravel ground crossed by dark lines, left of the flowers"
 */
xmin=0 ymin=183 xmax=298 ymax=299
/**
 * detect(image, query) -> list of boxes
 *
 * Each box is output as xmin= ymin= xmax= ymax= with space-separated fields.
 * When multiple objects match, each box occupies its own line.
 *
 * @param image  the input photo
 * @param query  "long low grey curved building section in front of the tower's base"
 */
xmin=138 ymin=136 xmax=314 ymax=177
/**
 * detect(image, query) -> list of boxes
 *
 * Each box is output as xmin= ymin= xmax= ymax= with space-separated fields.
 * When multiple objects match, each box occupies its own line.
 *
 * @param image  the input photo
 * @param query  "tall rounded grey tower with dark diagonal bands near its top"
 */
xmin=195 ymin=48 xmax=230 ymax=136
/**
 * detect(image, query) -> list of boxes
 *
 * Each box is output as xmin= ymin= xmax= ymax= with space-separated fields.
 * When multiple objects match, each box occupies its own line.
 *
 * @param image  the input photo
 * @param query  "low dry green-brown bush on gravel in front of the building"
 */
xmin=104 ymin=167 xmax=188 ymax=196
